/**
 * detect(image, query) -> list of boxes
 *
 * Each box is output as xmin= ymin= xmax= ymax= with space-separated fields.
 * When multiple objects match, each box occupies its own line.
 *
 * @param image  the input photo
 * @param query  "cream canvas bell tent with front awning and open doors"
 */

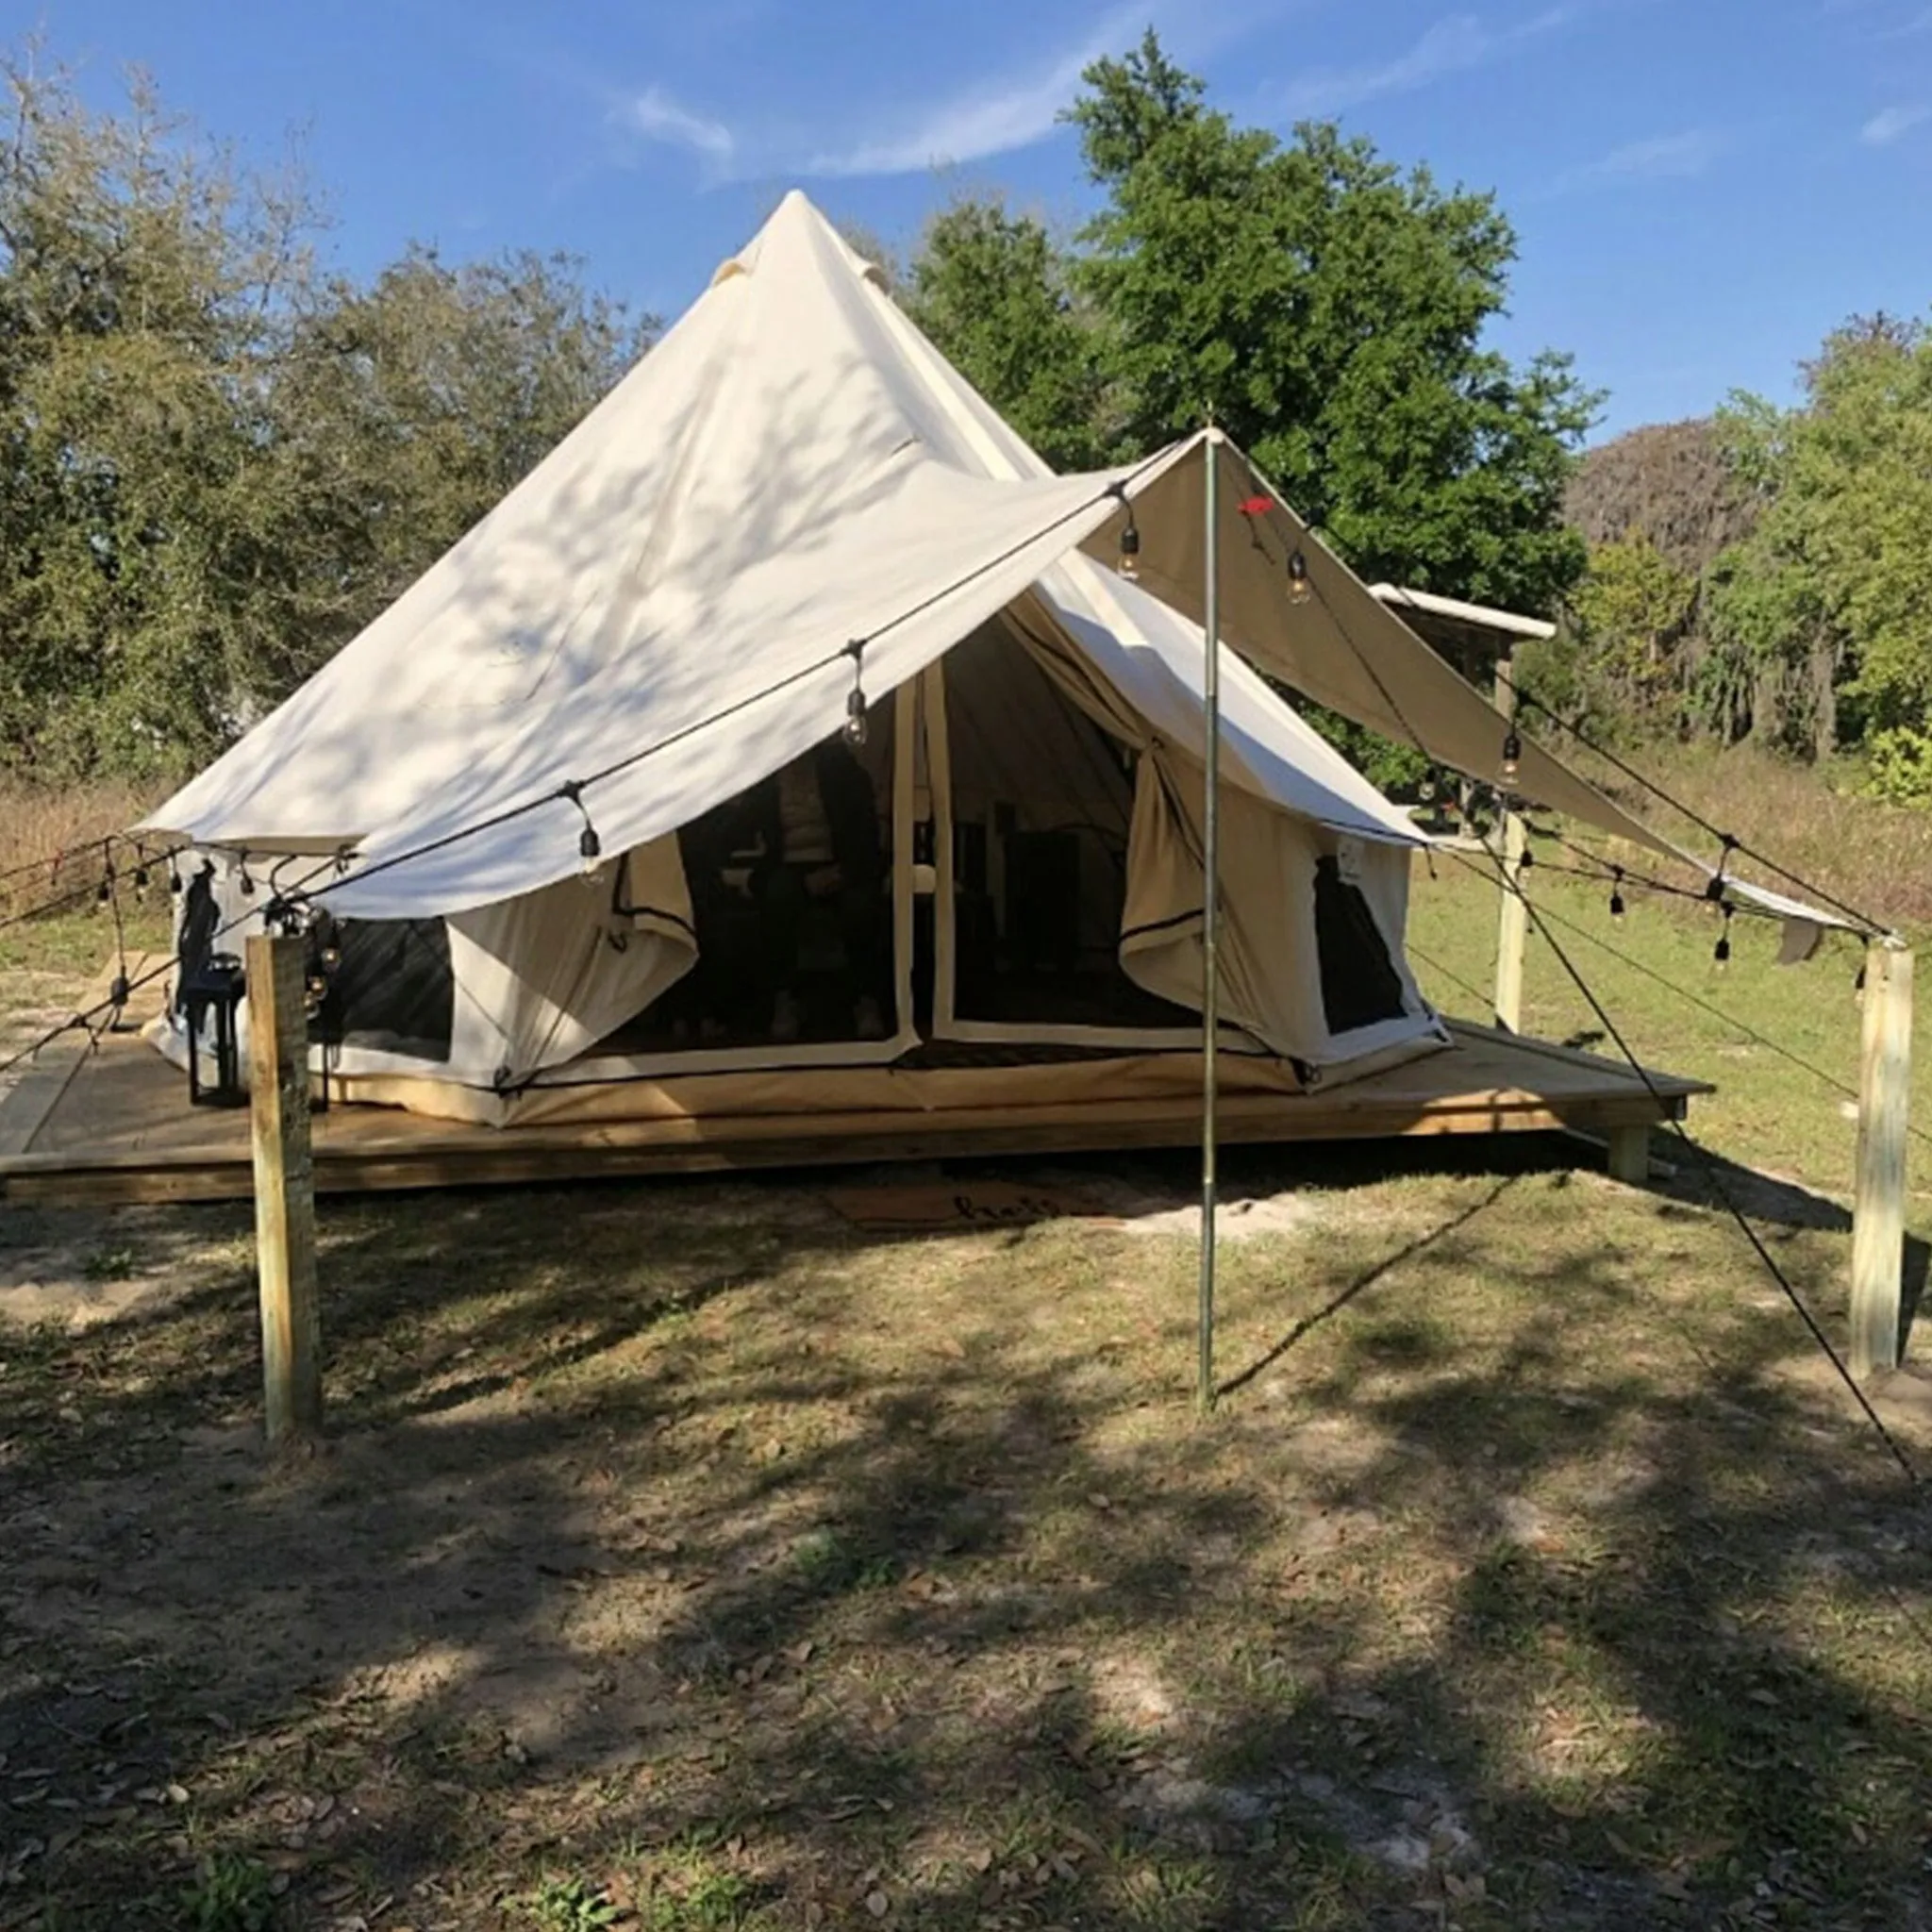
xmin=143 ymin=193 xmax=1839 ymax=1124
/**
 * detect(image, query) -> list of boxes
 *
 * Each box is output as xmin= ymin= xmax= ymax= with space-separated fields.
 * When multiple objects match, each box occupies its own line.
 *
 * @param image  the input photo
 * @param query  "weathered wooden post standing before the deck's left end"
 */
xmin=247 ymin=935 xmax=323 ymax=1445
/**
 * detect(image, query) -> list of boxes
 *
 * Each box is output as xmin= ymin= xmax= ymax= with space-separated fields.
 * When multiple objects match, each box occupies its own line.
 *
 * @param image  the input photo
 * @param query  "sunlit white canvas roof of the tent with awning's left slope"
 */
xmin=149 ymin=193 xmax=1416 ymax=916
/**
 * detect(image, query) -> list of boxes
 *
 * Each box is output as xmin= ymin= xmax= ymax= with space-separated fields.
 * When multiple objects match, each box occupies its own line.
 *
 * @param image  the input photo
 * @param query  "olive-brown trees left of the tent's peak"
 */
xmin=0 ymin=50 xmax=636 ymax=774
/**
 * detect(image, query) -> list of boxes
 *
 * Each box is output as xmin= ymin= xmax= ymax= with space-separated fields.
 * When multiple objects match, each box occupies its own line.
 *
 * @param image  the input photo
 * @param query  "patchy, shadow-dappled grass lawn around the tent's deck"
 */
xmin=0 ymin=863 xmax=1932 ymax=1932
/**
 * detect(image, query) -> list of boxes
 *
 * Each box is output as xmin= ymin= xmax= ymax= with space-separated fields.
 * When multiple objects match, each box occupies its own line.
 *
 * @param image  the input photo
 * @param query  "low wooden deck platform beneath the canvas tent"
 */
xmin=0 ymin=966 xmax=1712 ymax=1204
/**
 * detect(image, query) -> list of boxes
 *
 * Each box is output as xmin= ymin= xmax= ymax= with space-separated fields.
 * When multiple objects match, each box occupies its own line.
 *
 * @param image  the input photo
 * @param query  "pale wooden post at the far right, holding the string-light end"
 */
xmin=1851 ymin=939 xmax=1913 ymax=1375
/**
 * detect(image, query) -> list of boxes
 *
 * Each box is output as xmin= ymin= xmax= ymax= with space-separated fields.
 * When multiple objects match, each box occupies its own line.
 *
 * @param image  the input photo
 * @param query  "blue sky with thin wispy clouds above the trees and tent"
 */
xmin=23 ymin=0 xmax=1932 ymax=433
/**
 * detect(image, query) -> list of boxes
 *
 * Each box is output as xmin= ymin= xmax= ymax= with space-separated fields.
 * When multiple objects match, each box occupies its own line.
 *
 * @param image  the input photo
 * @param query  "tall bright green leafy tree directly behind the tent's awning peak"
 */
xmin=914 ymin=33 xmax=1594 ymax=610
